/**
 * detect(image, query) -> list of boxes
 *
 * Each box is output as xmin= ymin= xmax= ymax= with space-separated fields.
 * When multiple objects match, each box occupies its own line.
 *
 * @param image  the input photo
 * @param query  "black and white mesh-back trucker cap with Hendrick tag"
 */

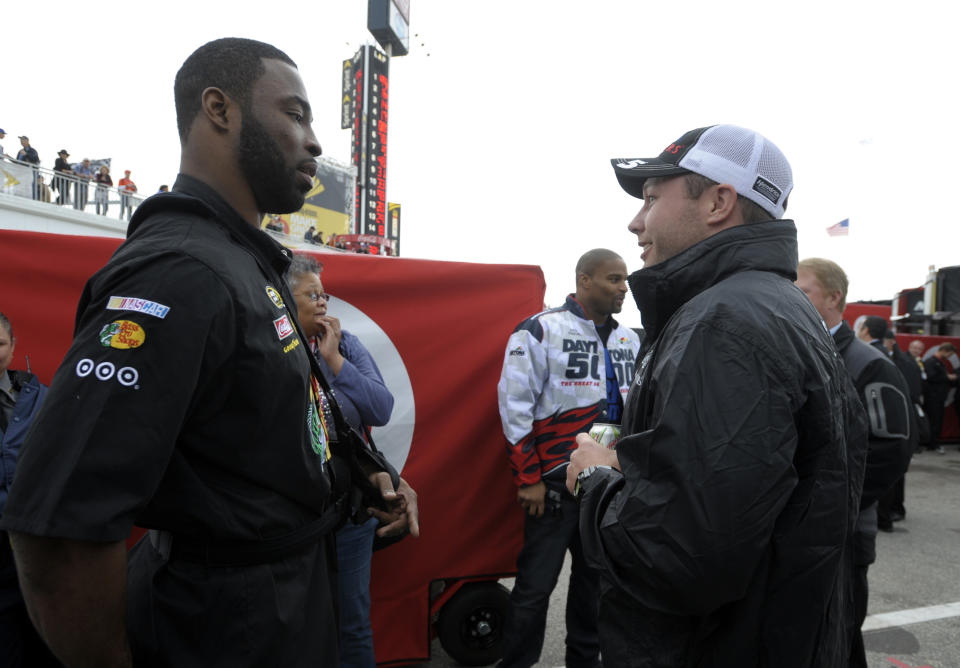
xmin=610 ymin=125 xmax=793 ymax=218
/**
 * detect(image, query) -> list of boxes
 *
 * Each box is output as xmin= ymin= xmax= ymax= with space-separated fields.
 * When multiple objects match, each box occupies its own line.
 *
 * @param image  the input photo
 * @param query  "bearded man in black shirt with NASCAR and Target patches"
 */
xmin=0 ymin=38 xmax=417 ymax=668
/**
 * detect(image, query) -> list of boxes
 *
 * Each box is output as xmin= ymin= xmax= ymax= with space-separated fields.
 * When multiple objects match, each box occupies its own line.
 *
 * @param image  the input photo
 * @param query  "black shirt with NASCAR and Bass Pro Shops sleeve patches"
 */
xmin=0 ymin=175 xmax=330 ymax=541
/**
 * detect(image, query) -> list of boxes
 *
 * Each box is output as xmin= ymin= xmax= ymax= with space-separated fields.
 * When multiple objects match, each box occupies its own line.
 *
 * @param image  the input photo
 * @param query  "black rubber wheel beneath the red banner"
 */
xmin=437 ymin=582 xmax=510 ymax=666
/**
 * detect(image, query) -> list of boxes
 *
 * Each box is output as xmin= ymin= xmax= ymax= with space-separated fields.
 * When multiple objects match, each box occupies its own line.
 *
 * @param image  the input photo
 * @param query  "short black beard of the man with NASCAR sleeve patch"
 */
xmin=239 ymin=106 xmax=306 ymax=213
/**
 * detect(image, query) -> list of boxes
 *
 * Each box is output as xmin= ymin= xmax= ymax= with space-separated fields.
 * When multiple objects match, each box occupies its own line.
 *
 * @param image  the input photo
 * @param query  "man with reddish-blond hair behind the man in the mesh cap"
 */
xmin=797 ymin=258 xmax=916 ymax=668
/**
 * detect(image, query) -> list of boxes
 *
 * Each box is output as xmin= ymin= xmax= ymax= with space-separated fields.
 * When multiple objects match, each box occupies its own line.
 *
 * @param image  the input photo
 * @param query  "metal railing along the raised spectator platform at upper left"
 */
xmin=0 ymin=160 xmax=145 ymax=220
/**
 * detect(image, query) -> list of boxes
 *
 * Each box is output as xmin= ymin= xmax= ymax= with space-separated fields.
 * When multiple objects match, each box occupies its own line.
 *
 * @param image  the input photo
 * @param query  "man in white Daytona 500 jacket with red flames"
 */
xmin=497 ymin=248 xmax=640 ymax=668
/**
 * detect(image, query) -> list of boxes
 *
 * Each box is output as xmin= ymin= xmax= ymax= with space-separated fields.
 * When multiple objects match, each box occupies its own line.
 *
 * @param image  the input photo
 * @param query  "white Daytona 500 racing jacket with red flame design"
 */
xmin=497 ymin=295 xmax=640 ymax=486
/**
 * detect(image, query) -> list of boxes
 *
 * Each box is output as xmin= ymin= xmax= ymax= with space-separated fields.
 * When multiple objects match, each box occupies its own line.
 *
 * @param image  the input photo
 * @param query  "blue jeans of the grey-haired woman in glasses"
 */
xmin=337 ymin=517 xmax=377 ymax=668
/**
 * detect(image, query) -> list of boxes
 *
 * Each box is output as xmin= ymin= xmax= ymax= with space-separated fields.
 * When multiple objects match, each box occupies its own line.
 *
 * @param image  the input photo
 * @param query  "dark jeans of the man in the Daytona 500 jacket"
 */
xmin=499 ymin=481 xmax=600 ymax=668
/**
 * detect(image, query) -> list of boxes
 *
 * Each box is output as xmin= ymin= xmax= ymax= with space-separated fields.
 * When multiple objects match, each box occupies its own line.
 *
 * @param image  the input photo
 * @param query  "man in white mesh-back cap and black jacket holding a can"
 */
xmin=567 ymin=125 xmax=865 ymax=668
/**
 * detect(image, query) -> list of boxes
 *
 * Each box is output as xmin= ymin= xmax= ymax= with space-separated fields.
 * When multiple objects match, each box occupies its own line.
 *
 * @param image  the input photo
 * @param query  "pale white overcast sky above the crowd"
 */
xmin=0 ymin=0 xmax=960 ymax=326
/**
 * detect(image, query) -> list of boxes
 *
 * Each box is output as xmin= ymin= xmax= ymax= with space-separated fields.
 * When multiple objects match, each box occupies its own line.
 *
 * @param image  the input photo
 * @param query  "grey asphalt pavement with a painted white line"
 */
xmin=410 ymin=444 xmax=960 ymax=668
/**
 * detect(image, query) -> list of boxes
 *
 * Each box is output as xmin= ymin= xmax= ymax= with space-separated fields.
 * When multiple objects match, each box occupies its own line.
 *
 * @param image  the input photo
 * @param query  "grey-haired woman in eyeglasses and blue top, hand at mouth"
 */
xmin=286 ymin=254 xmax=393 ymax=668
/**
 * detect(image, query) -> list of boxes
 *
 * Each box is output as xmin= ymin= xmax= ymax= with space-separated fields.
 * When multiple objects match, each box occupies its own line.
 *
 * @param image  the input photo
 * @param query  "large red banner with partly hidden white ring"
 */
xmin=0 ymin=230 xmax=545 ymax=663
